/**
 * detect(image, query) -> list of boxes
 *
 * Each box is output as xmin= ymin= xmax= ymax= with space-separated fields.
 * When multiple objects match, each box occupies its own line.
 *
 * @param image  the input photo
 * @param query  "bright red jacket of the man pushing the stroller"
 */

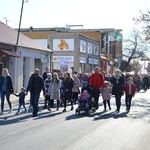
xmin=89 ymin=73 xmax=104 ymax=89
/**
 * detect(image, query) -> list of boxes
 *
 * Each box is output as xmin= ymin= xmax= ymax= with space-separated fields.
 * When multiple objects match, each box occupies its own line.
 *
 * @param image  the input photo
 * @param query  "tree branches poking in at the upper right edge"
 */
xmin=133 ymin=10 xmax=150 ymax=41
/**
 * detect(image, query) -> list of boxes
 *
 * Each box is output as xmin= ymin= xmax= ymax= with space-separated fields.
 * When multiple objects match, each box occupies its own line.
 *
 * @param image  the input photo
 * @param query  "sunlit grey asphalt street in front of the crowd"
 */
xmin=0 ymin=90 xmax=150 ymax=150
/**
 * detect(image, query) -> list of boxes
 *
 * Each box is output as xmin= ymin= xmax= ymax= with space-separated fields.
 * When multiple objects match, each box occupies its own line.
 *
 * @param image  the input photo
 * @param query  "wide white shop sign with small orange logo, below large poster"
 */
xmin=53 ymin=56 xmax=74 ymax=62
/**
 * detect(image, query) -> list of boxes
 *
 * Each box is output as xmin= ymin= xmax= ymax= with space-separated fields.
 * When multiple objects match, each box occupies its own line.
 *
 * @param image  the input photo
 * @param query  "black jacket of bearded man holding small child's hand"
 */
xmin=27 ymin=74 xmax=45 ymax=94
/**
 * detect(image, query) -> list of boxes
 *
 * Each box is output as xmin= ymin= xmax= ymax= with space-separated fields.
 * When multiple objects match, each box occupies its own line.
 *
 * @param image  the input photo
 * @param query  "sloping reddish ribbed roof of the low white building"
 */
xmin=0 ymin=21 xmax=51 ymax=52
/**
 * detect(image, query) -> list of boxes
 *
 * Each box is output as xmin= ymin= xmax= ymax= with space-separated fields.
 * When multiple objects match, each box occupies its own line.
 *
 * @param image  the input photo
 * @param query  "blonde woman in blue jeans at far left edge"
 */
xmin=0 ymin=68 xmax=14 ymax=115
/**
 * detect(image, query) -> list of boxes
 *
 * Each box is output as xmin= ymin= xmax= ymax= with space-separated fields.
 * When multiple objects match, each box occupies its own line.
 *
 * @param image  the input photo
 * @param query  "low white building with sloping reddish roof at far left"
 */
xmin=0 ymin=22 xmax=52 ymax=92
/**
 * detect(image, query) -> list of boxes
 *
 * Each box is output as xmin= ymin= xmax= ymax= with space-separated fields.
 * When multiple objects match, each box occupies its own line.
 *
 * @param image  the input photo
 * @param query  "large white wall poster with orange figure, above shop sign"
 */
xmin=53 ymin=39 xmax=74 ymax=51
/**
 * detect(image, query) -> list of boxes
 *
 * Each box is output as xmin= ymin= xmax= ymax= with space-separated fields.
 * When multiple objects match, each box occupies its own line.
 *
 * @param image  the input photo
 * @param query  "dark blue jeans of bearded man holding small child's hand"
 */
xmin=30 ymin=93 xmax=40 ymax=115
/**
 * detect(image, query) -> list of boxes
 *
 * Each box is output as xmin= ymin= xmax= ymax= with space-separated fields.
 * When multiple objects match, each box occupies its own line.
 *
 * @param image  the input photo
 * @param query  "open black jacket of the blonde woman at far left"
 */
xmin=0 ymin=75 xmax=14 ymax=94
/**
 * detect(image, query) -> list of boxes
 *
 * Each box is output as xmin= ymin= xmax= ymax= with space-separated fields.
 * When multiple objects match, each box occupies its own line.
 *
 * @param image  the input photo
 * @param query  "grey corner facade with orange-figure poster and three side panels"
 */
xmin=48 ymin=33 xmax=100 ymax=74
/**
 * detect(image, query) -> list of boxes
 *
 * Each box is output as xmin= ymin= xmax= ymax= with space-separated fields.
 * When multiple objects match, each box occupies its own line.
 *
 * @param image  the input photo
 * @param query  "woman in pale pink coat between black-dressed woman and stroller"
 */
xmin=72 ymin=75 xmax=80 ymax=104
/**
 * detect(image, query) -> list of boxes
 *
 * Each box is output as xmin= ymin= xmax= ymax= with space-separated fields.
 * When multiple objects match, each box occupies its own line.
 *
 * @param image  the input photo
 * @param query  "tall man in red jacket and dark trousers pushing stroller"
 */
xmin=89 ymin=66 xmax=104 ymax=112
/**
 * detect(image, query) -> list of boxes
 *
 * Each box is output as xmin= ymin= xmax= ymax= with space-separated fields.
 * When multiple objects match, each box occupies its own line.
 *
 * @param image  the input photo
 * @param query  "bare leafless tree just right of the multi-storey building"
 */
xmin=122 ymin=29 xmax=148 ymax=71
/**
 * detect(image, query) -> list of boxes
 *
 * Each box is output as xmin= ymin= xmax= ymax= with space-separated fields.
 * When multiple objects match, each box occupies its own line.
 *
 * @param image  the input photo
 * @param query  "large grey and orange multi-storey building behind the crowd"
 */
xmin=21 ymin=28 xmax=122 ymax=73
